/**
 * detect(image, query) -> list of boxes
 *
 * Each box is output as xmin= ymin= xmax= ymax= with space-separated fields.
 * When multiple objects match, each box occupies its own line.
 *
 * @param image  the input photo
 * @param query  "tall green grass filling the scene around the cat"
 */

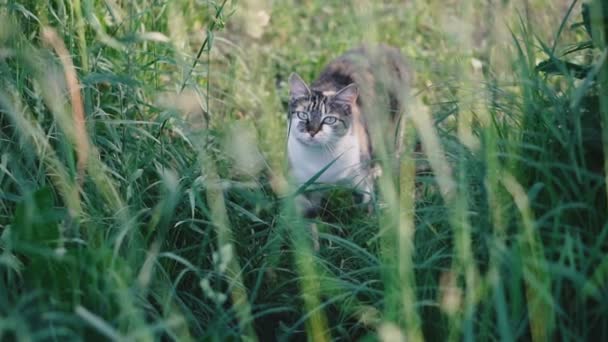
xmin=0 ymin=0 xmax=608 ymax=341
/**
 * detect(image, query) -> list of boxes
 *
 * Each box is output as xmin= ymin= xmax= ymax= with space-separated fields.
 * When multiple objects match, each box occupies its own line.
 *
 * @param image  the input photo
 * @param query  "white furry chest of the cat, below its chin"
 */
xmin=287 ymin=135 xmax=361 ymax=184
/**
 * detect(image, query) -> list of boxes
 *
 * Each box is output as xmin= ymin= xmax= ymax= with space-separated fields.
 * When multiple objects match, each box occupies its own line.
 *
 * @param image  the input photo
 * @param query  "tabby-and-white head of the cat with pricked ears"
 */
xmin=289 ymin=73 xmax=358 ymax=146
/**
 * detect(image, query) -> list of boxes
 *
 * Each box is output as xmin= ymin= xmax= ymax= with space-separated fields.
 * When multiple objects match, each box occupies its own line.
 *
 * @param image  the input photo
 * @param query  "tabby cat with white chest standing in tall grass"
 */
xmin=287 ymin=45 xmax=411 ymax=217
